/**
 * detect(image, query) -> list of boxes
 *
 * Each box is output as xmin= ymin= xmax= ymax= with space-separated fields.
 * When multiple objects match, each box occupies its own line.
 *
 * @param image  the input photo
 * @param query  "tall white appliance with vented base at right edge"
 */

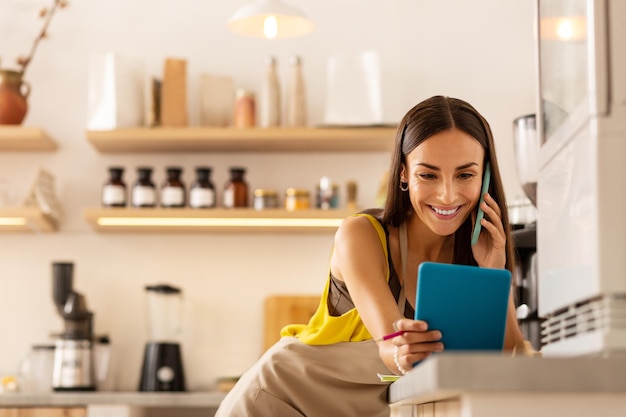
xmin=536 ymin=0 xmax=626 ymax=356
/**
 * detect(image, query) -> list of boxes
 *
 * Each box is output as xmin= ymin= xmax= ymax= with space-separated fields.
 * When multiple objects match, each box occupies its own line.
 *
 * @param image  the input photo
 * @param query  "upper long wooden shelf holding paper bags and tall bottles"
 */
xmin=87 ymin=127 xmax=396 ymax=153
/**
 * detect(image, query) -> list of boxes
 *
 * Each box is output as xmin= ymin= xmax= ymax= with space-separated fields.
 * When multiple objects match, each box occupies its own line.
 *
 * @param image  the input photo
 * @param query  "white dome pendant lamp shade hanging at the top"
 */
xmin=228 ymin=0 xmax=315 ymax=39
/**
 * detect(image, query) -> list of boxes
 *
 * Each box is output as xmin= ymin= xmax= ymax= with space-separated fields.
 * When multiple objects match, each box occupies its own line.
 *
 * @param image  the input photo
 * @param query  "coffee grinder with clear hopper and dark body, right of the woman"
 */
xmin=509 ymin=114 xmax=542 ymax=350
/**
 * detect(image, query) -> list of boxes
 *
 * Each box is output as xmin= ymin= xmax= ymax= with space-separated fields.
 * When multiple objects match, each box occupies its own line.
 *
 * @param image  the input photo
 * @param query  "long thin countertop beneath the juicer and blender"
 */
xmin=0 ymin=391 xmax=226 ymax=408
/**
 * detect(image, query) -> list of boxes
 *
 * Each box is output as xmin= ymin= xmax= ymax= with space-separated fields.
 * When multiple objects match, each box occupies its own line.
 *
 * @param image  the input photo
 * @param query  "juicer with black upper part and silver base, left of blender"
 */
xmin=52 ymin=262 xmax=96 ymax=391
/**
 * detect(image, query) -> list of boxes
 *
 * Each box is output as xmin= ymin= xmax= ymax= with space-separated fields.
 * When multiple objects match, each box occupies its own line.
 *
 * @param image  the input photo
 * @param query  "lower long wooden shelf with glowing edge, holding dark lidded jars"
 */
xmin=83 ymin=208 xmax=352 ymax=233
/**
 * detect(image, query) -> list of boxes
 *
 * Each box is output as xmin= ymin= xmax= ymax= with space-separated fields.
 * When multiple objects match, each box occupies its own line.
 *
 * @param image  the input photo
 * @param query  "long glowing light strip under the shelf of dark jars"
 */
xmin=97 ymin=217 xmax=343 ymax=227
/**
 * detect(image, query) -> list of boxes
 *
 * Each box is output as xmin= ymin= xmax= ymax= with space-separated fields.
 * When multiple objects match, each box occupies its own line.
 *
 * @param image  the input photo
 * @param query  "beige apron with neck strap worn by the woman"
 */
xmin=215 ymin=225 xmax=407 ymax=417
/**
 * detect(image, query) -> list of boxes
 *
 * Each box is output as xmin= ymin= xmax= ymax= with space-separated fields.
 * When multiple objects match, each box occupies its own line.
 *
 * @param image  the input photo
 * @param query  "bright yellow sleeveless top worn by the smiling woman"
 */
xmin=280 ymin=213 xmax=389 ymax=345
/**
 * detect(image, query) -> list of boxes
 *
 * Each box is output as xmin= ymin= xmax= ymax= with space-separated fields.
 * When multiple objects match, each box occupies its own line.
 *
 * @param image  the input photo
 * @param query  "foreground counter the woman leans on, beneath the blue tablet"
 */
xmin=389 ymin=354 xmax=626 ymax=417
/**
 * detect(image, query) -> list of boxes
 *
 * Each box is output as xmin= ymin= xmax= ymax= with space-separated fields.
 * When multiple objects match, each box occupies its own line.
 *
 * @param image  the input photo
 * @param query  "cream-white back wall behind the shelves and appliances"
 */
xmin=0 ymin=0 xmax=535 ymax=390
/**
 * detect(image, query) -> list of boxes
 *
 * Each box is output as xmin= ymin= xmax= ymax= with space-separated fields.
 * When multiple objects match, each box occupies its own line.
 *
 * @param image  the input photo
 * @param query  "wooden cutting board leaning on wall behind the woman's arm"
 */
xmin=263 ymin=295 xmax=320 ymax=352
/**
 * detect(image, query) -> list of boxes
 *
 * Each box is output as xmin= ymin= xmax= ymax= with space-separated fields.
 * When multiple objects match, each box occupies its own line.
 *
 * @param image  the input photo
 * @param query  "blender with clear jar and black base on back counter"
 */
xmin=139 ymin=284 xmax=185 ymax=391
